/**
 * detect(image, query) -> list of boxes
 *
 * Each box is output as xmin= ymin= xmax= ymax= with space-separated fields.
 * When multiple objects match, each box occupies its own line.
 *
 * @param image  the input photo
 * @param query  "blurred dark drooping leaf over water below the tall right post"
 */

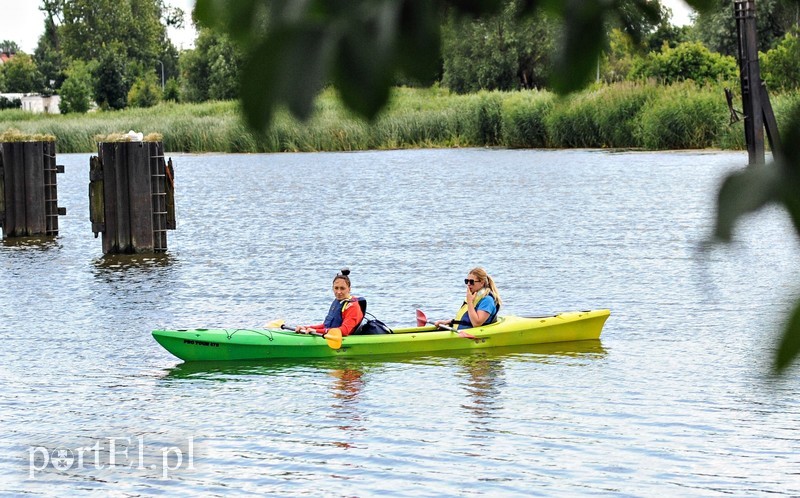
xmin=714 ymin=163 xmax=783 ymax=242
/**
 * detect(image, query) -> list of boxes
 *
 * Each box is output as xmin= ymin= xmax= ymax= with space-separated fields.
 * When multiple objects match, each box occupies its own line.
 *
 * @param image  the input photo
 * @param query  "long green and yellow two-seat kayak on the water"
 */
xmin=153 ymin=309 xmax=611 ymax=361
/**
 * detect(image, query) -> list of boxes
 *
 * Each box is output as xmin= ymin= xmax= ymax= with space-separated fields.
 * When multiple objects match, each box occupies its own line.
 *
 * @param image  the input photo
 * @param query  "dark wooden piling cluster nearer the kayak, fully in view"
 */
xmin=89 ymin=141 xmax=175 ymax=254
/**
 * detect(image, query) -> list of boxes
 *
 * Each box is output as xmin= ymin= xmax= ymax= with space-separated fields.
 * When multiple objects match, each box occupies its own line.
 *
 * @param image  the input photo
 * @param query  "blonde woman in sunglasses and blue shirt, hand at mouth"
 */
xmin=435 ymin=268 xmax=502 ymax=329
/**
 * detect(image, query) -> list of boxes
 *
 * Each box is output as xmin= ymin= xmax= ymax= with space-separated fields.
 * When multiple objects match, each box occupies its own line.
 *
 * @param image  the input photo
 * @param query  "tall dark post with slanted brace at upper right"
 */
xmin=733 ymin=0 xmax=781 ymax=166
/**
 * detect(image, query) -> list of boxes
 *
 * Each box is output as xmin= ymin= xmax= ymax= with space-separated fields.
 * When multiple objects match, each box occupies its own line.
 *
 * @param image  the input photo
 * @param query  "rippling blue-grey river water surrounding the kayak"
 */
xmin=0 ymin=149 xmax=800 ymax=496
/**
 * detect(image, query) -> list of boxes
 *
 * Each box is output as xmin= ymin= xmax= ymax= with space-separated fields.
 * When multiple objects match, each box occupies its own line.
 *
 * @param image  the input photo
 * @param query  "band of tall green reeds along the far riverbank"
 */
xmin=0 ymin=81 xmax=800 ymax=153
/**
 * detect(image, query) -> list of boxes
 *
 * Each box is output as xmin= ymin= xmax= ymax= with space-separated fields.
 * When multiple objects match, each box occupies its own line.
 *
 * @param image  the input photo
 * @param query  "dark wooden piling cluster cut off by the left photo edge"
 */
xmin=0 ymin=141 xmax=67 ymax=238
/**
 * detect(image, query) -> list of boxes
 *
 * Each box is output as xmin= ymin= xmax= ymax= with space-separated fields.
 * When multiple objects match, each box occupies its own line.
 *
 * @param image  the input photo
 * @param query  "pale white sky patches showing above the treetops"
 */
xmin=0 ymin=0 xmax=692 ymax=54
